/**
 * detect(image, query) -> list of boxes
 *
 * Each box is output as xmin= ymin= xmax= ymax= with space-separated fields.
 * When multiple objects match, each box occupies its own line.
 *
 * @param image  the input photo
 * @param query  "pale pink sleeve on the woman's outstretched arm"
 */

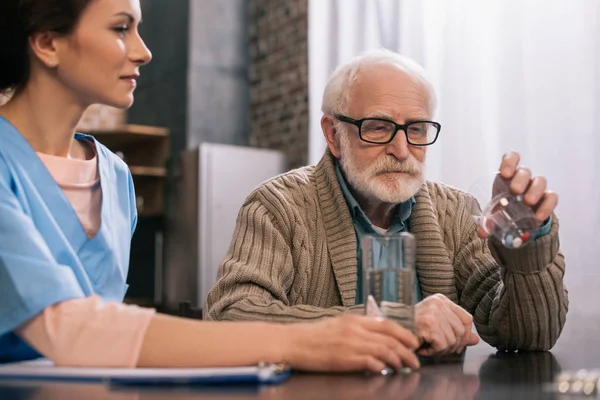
xmin=15 ymin=295 xmax=155 ymax=368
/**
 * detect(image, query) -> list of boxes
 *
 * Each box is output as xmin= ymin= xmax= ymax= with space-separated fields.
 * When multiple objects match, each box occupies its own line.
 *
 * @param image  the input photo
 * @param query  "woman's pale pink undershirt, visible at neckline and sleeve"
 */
xmin=16 ymin=145 xmax=155 ymax=367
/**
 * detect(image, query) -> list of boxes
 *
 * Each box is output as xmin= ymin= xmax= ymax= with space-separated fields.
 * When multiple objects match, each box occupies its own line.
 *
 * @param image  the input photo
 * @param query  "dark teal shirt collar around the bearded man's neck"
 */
xmin=334 ymin=159 xmax=416 ymax=234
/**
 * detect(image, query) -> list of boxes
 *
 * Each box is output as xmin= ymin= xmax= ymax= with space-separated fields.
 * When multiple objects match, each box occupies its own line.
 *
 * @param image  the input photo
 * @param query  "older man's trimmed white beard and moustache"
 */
xmin=339 ymin=134 xmax=425 ymax=204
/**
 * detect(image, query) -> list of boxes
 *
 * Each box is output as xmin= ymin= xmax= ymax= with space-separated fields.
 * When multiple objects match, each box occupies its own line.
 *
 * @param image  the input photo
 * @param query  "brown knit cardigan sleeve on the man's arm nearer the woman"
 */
xmin=205 ymin=196 xmax=364 ymax=323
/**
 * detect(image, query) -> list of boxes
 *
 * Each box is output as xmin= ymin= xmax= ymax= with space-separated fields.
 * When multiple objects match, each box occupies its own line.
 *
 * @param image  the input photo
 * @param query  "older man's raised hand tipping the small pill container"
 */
xmin=477 ymin=151 xmax=558 ymax=238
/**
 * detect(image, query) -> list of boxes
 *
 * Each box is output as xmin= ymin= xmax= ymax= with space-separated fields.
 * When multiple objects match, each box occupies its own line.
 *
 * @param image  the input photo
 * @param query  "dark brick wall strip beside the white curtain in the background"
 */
xmin=249 ymin=0 xmax=308 ymax=168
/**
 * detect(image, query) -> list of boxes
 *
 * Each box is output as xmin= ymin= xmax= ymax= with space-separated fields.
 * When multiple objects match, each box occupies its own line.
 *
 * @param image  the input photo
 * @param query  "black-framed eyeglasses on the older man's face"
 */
xmin=334 ymin=114 xmax=442 ymax=146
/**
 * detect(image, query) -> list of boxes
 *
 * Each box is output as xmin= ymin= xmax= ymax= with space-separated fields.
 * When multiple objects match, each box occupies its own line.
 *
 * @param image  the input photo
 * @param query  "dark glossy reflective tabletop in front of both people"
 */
xmin=0 ymin=314 xmax=600 ymax=400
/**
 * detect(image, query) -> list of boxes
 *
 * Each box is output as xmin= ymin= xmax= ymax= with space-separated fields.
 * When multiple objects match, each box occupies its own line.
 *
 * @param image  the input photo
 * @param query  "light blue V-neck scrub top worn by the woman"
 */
xmin=0 ymin=117 xmax=137 ymax=362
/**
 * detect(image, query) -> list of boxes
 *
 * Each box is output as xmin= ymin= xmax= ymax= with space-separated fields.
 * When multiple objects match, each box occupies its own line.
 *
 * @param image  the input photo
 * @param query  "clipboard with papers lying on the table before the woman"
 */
xmin=0 ymin=359 xmax=292 ymax=386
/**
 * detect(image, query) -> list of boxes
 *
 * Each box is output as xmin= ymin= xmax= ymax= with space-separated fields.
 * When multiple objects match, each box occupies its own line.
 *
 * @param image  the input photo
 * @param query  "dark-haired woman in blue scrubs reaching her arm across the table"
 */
xmin=0 ymin=0 xmax=418 ymax=371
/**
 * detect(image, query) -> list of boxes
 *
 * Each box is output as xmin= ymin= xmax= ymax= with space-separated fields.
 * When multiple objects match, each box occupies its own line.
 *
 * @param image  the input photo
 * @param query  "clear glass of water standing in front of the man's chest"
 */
xmin=361 ymin=233 xmax=417 ymax=333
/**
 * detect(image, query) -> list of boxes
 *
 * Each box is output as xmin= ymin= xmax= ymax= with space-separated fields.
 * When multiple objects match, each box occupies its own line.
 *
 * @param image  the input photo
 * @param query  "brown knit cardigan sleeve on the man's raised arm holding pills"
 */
xmin=448 ymin=193 xmax=568 ymax=351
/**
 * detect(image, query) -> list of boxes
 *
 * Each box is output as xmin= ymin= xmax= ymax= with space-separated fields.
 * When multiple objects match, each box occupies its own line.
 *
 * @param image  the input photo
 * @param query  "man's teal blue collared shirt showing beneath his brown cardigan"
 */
xmin=335 ymin=160 xmax=421 ymax=304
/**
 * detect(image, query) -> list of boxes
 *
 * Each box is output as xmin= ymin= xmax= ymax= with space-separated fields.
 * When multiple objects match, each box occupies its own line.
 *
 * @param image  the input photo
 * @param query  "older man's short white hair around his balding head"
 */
xmin=321 ymin=49 xmax=437 ymax=118
